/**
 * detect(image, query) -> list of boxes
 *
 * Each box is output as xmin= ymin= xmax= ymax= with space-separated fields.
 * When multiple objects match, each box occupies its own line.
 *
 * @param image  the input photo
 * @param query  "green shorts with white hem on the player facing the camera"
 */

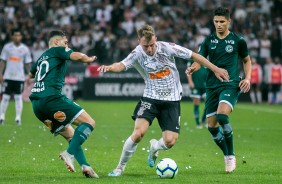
xmin=205 ymin=86 xmax=240 ymax=117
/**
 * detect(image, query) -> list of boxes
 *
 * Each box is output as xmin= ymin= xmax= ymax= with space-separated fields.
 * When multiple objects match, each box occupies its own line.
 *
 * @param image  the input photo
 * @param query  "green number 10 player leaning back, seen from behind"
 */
xmin=29 ymin=30 xmax=99 ymax=178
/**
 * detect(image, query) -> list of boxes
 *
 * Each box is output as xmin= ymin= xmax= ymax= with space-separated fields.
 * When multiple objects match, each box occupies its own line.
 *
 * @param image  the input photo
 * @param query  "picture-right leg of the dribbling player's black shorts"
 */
xmin=157 ymin=101 xmax=181 ymax=133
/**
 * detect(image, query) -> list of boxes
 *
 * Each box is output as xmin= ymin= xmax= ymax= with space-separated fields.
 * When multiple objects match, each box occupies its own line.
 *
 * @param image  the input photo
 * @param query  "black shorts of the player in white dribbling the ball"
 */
xmin=132 ymin=97 xmax=180 ymax=133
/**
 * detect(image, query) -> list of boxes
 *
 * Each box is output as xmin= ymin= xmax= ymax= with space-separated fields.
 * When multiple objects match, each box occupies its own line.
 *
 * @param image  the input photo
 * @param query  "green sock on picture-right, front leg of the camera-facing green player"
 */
xmin=216 ymin=114 xmax=234 ymax=155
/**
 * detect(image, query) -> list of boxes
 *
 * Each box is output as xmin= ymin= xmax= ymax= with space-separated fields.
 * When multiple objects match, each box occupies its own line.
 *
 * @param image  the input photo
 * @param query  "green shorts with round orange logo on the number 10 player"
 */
xmin=31 ymin=95 xmax=84 ymax=135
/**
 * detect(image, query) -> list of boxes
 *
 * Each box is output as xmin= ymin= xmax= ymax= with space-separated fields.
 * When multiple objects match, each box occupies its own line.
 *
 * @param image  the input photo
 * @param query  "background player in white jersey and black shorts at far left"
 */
xmin=0 ymin=29 xmax=32 ymax=125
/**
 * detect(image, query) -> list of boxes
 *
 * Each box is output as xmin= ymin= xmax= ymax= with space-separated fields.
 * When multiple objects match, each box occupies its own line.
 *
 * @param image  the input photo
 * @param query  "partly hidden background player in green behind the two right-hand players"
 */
xmin=187 ymin=63 xmax=207 ymax=129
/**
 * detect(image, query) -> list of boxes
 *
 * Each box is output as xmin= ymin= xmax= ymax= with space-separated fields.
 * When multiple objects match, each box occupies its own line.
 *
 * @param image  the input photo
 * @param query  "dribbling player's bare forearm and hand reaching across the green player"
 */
xmin=189 ymin=52 xmax=229 ymax=81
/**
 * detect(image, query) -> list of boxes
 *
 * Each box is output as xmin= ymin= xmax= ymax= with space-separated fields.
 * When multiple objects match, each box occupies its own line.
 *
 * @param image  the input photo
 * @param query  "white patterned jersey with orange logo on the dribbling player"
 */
xmin=121 ymin=42 xmax=192 ymax=101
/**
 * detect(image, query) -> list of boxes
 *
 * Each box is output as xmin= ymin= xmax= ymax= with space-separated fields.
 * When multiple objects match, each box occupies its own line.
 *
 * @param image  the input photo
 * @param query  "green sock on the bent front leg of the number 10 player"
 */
xmin=67 ymin=123 xmax=93 ymax=166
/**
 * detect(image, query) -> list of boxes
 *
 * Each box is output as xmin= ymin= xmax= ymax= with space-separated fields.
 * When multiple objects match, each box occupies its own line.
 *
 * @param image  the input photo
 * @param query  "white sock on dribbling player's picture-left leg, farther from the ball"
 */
xmin=118 ymin=137 xmax=138 ymax=169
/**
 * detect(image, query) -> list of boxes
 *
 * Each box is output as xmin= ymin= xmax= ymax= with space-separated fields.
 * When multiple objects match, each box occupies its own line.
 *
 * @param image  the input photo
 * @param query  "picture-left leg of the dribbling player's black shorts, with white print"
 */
xmin=132 ymin=97 xmax=159 ymax=125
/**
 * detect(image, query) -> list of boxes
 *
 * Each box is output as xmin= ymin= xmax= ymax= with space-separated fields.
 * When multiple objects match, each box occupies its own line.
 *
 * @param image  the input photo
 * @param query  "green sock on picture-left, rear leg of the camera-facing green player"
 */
xmin=208 ymin=127 xmax=228 ymax=156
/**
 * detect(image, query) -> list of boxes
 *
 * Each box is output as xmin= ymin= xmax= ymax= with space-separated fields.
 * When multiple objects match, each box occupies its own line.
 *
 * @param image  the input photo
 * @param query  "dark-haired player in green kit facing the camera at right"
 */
xmin=186 ymin=7 xmax=252 ymax=173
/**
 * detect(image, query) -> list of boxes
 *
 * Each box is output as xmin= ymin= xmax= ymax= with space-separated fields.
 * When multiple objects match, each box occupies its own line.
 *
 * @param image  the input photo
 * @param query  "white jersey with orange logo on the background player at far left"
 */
xmin=1 ymin=42 xmax=32 ymax=81
